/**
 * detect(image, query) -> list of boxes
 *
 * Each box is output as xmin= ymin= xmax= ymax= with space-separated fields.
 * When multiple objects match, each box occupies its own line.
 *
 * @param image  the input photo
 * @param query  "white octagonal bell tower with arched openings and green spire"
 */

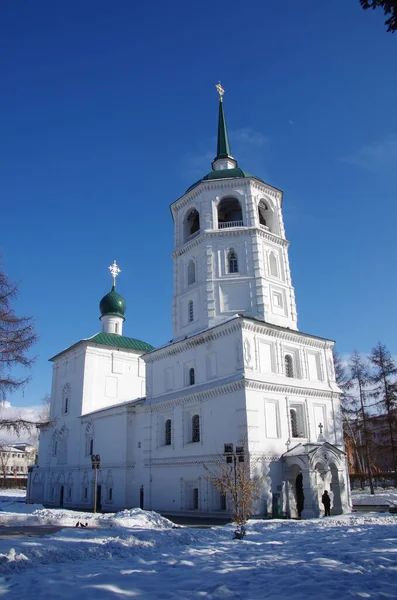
xmin=171 ymin=84 xmax=298 ymax=340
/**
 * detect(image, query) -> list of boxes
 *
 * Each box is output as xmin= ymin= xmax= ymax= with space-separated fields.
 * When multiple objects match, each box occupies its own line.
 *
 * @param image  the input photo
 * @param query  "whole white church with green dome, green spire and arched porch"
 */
xmin=29 ymin=85 xmax=350 ymax=518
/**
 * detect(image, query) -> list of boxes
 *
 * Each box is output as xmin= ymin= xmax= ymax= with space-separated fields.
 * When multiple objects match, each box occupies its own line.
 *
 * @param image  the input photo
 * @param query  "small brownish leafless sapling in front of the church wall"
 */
xmin=204 ymin=437 xmax=263 ymax=525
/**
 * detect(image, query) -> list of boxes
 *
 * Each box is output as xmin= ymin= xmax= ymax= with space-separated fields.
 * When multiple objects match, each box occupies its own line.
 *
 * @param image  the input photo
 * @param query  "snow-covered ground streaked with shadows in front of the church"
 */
xmin=0 ymin=492 xmax=397 ymax=600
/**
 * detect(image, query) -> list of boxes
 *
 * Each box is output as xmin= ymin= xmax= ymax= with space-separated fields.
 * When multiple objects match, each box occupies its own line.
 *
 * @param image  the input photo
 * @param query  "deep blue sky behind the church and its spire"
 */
xmin=0 ymin=0 xmax=397 ymax=406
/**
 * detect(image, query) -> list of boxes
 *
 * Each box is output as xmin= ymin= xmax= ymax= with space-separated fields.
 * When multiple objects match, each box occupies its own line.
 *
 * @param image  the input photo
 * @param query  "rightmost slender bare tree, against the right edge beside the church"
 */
xmin=370 ymin=342 xmax=397 ymax=487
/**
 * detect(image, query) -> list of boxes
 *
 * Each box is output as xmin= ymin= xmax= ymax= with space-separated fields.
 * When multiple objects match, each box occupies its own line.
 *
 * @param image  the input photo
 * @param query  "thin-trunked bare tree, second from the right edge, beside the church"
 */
xmin=349 ymin=350 xmax=375 ymax=494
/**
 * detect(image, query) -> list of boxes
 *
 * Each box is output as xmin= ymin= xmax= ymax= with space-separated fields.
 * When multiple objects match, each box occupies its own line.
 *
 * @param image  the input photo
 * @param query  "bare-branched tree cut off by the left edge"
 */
xmin=0 ymin=270 xmax=37 ymax=400
